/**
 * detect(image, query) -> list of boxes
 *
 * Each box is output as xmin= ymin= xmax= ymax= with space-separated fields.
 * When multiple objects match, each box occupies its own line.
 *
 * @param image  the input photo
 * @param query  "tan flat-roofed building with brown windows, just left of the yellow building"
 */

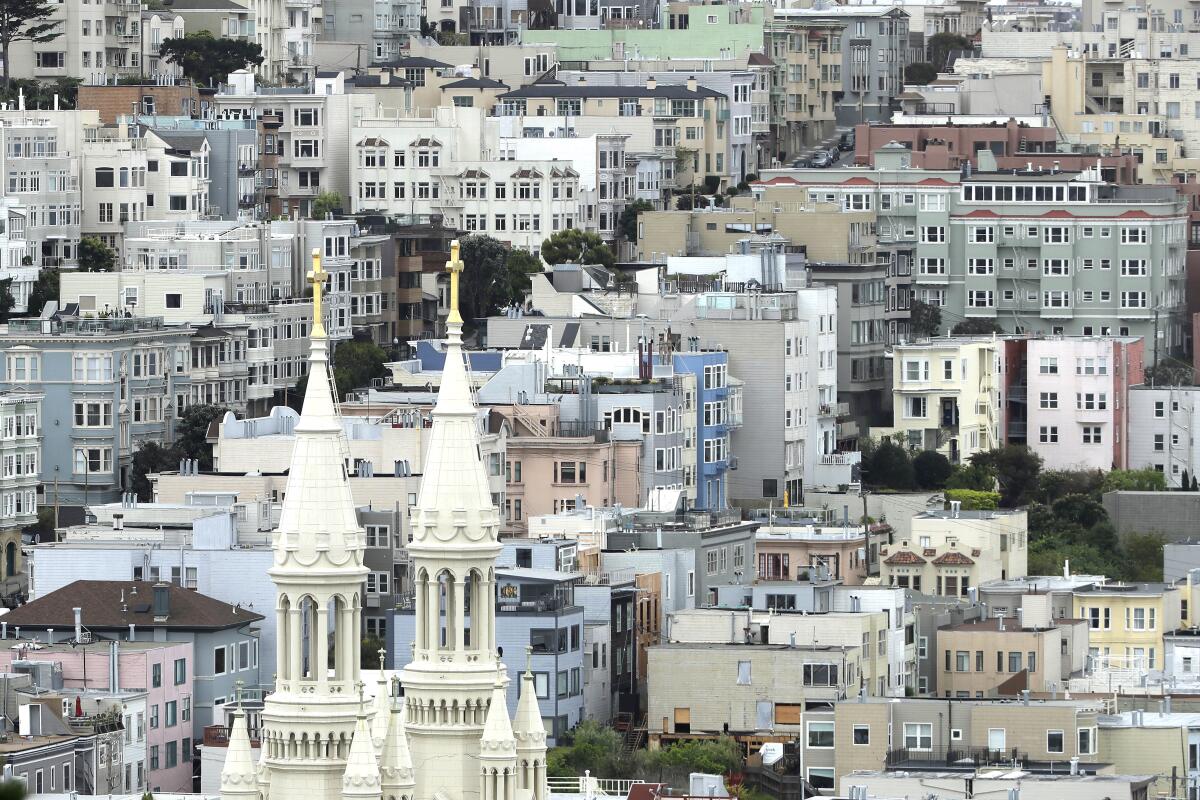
xmin=937 ymin=604 xmax=1087 ymax=698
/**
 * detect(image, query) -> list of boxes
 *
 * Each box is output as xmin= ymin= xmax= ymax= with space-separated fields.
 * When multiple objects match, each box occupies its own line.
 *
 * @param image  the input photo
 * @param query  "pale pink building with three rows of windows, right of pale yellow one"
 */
xmin=1022 ymin=336 xmax=1145 ymax=470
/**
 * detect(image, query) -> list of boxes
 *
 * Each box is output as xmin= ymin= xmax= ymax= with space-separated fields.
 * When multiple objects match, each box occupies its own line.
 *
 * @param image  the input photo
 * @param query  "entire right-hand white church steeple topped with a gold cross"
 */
xmin=403 ymin=242 xmax=511 ymax=800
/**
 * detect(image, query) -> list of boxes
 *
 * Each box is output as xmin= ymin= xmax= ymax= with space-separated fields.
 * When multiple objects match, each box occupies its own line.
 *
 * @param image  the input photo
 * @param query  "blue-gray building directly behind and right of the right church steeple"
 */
xmin=391 ymin=563 xmax=584 ymax=746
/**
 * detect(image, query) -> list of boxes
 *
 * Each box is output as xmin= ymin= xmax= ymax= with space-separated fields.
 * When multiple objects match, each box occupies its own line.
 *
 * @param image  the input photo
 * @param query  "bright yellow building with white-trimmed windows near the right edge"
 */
xmin=1074 ymin=583 xmax=1183 ymax=673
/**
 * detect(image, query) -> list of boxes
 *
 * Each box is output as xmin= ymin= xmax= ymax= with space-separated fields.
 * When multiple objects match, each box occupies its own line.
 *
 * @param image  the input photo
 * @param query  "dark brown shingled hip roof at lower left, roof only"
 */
xmin=5 ymin=581 xmax=263 ymax=631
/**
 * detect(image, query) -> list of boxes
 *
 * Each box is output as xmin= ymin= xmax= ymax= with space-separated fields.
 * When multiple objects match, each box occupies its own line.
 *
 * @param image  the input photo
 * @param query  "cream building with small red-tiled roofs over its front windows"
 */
xmin=880 ymin=510 xmax=1028 ymax=597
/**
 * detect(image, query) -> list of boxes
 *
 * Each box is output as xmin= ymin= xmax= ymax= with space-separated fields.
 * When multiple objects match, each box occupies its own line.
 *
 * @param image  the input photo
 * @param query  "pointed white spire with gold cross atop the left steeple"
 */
xmin=277 ymin=257 xmax=366 ymax=573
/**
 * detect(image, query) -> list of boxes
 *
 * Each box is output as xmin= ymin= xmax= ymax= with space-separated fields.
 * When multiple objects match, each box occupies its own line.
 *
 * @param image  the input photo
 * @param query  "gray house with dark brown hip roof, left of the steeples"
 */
xmin=5 ymin=581 xmax=263 ymax=739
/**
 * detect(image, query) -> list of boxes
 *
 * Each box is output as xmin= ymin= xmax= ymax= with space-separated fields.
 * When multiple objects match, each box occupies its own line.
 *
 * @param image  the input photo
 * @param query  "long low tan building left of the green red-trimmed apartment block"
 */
xmin=635 ymin=197 xmax=876 ymax=264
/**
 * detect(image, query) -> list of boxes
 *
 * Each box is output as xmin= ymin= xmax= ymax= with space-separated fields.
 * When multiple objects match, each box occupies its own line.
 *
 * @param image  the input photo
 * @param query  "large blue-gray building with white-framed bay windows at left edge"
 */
xmin=0 ymin=314 xmax=192 ymax=506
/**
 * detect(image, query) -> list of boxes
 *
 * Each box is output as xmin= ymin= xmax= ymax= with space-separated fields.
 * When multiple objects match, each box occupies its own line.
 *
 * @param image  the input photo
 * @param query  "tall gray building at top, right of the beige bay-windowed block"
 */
xmin=775 ymin=5 xmax=910 ymax=125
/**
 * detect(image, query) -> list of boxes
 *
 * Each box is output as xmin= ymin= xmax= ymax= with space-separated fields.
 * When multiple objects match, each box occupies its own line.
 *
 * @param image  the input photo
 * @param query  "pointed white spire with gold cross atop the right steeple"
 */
xmin=409 ymin=241 xmax=499 ymax=553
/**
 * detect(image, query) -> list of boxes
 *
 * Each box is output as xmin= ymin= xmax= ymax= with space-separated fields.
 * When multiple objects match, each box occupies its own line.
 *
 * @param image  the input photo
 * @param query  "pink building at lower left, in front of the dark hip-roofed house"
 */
xmin=0 ymin=628 xmax=194 ymax=792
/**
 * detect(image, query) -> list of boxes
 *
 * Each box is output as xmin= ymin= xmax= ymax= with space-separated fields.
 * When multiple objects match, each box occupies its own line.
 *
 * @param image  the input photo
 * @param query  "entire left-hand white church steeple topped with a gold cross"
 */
xmin=262 ymin=251 xmax=374 ymax=800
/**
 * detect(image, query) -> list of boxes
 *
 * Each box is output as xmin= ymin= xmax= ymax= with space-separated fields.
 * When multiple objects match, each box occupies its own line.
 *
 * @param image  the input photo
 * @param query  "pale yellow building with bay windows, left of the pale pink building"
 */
xmin=871 ymin=337 xmax=1004 ymax=463
